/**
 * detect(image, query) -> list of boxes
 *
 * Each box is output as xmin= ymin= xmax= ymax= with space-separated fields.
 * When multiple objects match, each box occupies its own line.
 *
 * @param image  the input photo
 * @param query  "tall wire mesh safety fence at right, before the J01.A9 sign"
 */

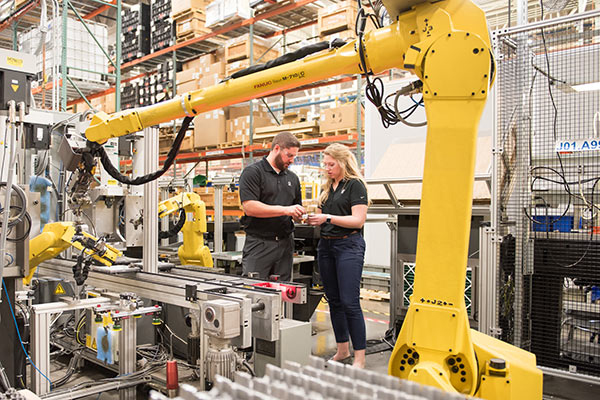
xmin=495 ymin=10 xmax=600 ymax=375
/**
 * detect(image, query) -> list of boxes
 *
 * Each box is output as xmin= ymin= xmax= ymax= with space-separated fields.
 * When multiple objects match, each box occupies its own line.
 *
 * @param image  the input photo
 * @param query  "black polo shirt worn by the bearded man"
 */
xmin=240 ymin=157 xmax=302 ymax=237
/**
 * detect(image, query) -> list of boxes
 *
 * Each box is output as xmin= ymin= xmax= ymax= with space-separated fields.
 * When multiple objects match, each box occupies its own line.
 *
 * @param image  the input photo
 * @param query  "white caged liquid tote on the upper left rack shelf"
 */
xmin=19 ymin=18 xmax=109 ymax=85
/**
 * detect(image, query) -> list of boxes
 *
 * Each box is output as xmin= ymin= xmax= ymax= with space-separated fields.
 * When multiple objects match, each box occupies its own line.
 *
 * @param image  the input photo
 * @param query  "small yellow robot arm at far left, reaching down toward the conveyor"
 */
xmin=23 ymin=222 xmax=122 ymax=285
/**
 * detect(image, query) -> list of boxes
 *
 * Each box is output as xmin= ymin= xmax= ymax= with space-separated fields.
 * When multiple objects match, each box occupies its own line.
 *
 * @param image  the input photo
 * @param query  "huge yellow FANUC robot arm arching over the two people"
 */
xmin=78 ymin=0 xmax=542 ymax=399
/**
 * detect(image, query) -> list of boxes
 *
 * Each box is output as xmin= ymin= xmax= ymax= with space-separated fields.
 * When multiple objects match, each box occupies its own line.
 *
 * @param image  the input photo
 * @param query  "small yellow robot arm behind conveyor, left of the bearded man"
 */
xmin=158 ymin=192 xmax=213 ymax=267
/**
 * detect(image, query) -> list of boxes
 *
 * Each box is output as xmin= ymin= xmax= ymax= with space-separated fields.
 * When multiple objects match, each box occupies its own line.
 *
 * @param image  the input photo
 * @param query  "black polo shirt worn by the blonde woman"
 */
xmin=321 ymin=179 xmax=369 ymax=236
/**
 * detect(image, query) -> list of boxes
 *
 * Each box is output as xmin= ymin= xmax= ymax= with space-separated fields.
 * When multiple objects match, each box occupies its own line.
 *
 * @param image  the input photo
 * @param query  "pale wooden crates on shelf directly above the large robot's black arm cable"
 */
xmin=225 ymin=34 xmax=279 ymax=76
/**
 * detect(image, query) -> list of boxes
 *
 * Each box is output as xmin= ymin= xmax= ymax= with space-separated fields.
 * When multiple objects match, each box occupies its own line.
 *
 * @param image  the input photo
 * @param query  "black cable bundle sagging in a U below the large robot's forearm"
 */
xmin=89 ymin=117 xmax=193 ymax=185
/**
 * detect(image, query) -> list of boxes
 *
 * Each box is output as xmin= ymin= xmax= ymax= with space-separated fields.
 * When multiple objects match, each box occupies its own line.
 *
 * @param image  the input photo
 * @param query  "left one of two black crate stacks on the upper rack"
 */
xmin=121 ymin=3 xmax=150 ymax=62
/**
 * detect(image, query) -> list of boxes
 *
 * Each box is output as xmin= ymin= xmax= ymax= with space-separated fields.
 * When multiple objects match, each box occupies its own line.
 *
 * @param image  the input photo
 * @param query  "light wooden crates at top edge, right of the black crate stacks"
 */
xmin=171 ymin=0 xmax=209 ymax=42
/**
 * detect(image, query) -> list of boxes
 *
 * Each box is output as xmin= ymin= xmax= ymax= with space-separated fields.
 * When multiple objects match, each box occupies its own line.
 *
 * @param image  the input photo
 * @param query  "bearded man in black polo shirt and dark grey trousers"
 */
xmin=240 ymin=132 xmax=306 ymax=281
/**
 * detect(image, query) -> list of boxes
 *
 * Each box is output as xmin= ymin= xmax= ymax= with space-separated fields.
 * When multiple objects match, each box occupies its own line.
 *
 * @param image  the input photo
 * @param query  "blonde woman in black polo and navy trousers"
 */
xmin=308 ymin=143 xmax=369 ymax=368
